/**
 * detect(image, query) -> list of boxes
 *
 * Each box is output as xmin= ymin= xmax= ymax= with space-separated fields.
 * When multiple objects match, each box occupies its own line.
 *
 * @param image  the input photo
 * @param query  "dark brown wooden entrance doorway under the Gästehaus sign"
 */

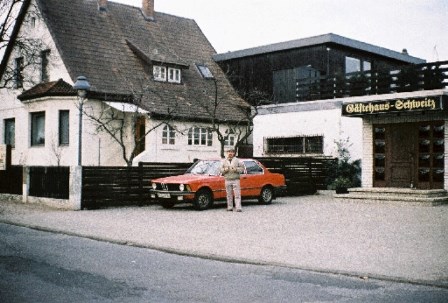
xmin=373 ymin=121 xmax=445 ymax=189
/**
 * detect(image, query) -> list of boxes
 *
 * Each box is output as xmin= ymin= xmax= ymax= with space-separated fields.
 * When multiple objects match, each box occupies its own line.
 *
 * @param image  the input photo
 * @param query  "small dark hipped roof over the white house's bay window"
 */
xmin=17 ymin=79 xmax=77 ymax=101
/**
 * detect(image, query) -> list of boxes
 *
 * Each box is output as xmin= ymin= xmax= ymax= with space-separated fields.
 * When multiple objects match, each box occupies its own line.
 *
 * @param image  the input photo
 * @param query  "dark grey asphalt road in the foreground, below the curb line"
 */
xmin=0 ymin=224 xmax=448 ymax=303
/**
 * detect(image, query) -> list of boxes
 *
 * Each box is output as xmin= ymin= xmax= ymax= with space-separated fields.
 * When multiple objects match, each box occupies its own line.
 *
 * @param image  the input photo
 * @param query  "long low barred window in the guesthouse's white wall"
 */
xmin=265 ymin=136 xmax=324 ymax=154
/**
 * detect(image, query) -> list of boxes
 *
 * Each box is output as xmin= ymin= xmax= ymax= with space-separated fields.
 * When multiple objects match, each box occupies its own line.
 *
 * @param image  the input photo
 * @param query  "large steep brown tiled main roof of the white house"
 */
xmin=34 ymin=0 xmax=247 ymax=120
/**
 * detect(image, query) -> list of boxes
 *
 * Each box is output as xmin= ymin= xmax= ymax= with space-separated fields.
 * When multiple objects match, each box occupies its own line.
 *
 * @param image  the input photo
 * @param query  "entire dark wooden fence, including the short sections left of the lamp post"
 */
xmin=0 ymin=158 xmax=334 ymax=209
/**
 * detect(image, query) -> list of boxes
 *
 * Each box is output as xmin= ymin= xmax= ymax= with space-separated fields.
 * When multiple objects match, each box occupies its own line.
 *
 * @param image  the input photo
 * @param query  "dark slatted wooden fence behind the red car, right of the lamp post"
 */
xmin=81 ymin=158 xmax=334 ymax=209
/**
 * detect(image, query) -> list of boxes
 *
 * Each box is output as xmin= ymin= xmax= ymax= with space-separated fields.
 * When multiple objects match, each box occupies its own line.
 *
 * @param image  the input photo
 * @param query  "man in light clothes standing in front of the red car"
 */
xmin=221 ymin=148 xmax=244 ymax=212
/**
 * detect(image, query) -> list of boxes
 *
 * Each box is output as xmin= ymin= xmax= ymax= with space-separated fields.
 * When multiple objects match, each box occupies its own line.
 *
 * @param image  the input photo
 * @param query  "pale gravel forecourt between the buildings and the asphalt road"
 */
xmin=0 ymin=194 xmax=448 ymax=288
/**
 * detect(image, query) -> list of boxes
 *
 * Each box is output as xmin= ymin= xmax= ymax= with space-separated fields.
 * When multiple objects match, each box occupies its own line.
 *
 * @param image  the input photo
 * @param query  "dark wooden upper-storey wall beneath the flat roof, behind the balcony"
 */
xmin=218 ymin=43 xmax=408 ymax=105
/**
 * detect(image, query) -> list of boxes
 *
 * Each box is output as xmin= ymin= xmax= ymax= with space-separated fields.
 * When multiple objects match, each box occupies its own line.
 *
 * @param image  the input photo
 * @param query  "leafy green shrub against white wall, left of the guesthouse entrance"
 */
xmin=327 ymin=139 xmax=361 ymax=194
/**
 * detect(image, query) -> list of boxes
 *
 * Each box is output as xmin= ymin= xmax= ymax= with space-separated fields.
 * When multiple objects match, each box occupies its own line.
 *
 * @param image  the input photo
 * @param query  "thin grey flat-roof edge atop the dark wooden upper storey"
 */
xmin=213 ymin=33 xmax=426 ymax=64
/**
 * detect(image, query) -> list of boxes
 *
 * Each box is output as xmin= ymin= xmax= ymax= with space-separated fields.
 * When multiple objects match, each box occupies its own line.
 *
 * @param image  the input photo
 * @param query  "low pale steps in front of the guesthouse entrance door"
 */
xmin=334 ymin=187 xmax=448 ymax=206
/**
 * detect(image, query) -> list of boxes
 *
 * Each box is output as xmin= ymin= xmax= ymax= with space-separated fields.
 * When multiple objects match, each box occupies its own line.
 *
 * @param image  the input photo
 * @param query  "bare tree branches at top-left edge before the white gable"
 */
xmin=0 ymin=0 xmax=46 ymax=88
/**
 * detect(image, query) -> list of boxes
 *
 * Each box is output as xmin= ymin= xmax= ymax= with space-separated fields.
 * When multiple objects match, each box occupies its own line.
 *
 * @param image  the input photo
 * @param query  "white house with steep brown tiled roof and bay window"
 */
xmin=0 ymin=0 xmax=250 ymax=166
